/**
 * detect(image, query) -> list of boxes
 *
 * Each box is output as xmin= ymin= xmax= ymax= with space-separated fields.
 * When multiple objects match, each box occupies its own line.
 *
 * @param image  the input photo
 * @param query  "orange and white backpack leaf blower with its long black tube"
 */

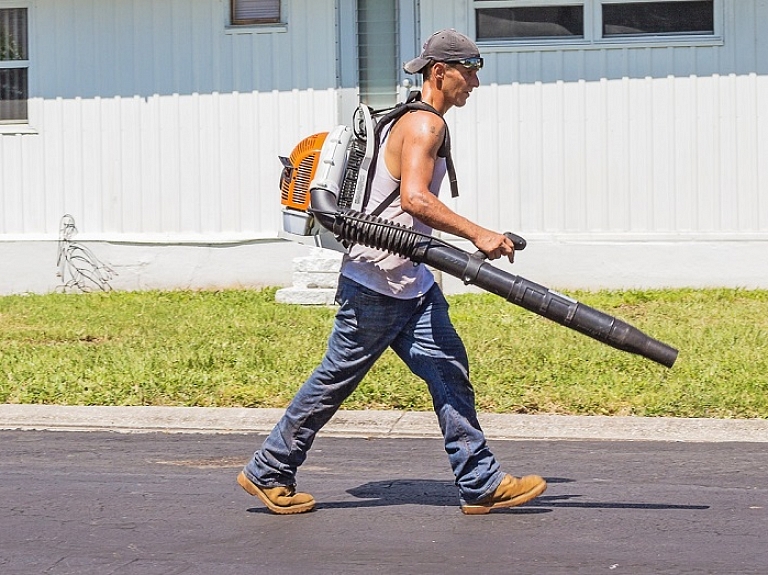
xmin=280 ymin=104 xmax=678 ymax=368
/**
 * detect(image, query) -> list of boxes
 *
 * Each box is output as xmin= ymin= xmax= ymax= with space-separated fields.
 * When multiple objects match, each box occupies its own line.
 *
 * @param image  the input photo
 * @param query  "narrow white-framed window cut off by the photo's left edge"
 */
xmin=0 ymin=8 xmax=29 ymax=124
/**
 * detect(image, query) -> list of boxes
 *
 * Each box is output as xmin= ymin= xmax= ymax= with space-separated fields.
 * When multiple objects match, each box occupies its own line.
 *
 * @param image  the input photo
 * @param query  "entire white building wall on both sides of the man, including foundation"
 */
xmin=0 ymin=0 xmax=768 ymax=293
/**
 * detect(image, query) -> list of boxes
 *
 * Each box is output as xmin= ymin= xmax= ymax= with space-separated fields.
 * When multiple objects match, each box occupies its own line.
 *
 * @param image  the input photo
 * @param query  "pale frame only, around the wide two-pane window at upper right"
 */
xmin=469 ymin=0 xmax=724 ymax=52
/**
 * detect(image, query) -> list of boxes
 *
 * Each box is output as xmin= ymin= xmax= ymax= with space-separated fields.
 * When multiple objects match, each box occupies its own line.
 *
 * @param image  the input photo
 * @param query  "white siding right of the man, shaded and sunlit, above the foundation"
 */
xmin=421 ymin=0 xmax=768 ymax=240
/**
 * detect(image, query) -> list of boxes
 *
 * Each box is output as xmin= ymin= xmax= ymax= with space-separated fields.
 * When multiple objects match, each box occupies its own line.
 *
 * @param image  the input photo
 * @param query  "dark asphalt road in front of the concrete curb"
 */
xmin=0 ymin=431 xmax=768 ymax=575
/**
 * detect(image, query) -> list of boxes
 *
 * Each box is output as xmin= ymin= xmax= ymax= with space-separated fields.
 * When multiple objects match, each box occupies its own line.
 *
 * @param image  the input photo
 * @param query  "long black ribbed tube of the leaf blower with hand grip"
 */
xmin=309 ymin=188 xmax=678 ymax=367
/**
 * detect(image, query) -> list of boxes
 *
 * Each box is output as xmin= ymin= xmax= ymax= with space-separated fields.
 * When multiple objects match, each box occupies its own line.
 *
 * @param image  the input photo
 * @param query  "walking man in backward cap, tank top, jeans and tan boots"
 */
xmin=238 ymin=30 xmax=547 ymax=514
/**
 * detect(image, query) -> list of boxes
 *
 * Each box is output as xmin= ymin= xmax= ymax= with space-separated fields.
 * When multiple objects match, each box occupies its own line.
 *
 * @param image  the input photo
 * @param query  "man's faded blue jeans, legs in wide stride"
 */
xmin=245 ymin=276 xmax=504 ymax=503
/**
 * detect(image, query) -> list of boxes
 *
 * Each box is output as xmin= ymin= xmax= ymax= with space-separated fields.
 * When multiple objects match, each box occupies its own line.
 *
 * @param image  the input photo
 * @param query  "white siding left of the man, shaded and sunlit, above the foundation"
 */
xmin=0 ymin=0 xmax=337 ymax=241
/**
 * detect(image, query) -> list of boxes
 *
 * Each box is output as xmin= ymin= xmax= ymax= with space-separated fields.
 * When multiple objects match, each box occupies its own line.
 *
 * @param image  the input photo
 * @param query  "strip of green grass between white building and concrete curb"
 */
xmin=0 ymin=289 xmax=768 ymax=418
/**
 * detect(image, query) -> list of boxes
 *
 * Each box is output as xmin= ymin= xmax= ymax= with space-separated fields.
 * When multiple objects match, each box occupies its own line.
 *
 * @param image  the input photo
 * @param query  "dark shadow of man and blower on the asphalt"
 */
xmin=249 ymin=477 xmax=709 ymax=514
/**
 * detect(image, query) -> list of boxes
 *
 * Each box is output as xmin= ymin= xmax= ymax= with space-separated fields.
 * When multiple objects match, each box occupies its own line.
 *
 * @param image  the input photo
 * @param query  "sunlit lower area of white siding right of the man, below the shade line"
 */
xmin=454 ymin=60 xmax=768 ymax=234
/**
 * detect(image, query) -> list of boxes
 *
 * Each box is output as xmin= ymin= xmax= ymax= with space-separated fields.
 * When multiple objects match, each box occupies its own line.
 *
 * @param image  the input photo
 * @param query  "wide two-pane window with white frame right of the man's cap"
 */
xmin=473 ymin=0 xmax=722 ymax=45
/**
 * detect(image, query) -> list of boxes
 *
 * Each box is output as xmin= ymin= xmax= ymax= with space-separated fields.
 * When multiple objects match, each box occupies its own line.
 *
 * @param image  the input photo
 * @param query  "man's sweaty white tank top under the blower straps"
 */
xmin=341 ymin=127 xmax=446 ymax=299
